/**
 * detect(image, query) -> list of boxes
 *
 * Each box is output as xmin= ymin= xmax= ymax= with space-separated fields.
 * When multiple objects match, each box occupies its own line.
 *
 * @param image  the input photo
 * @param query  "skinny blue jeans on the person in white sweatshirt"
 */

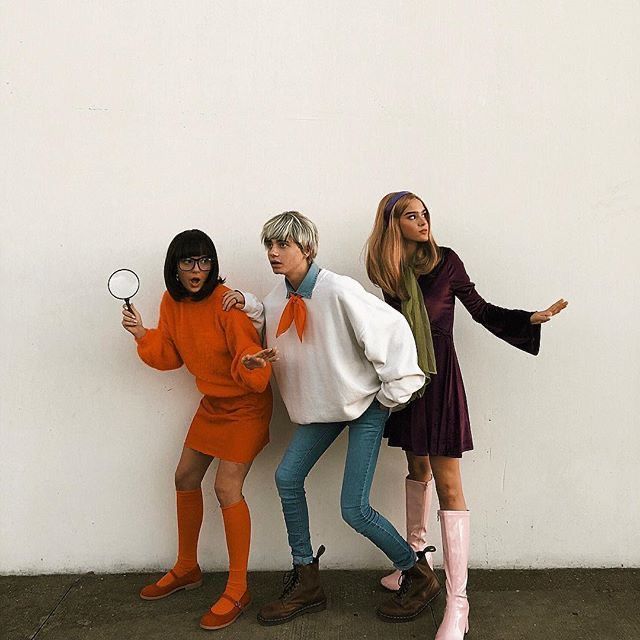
xmin=276 ymin=400 xmax=416 ymax=571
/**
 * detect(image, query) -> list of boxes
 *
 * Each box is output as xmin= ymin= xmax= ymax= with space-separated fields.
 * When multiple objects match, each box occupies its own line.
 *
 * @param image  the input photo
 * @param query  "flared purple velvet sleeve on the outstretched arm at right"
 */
xmin=447 ymin=250 xmax=541 ymax=355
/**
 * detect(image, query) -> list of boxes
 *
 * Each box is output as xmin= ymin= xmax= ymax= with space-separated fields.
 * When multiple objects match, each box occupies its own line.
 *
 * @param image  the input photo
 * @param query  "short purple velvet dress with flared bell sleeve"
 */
xmin=384 ymin=247 xmax=540 ymax=458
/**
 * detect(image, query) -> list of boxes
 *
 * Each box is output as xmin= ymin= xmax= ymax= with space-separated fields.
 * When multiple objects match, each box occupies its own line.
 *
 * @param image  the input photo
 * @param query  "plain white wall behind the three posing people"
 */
xmin=0 ymin=0 xmax=640 ymax=573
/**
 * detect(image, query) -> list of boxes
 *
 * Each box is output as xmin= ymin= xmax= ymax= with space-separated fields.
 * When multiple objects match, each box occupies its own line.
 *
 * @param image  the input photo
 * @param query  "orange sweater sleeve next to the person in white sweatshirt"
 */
xmin=222 ymin=308 xmax=271 ymax=393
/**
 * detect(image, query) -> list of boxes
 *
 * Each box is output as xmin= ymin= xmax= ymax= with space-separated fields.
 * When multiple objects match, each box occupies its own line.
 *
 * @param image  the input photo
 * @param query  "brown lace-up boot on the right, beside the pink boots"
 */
xmin=376 ymin=546 xmax=440 ymax=622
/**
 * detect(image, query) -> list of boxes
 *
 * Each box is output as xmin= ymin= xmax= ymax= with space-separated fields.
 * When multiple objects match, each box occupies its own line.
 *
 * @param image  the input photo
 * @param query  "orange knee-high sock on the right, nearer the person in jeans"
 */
xmin=211 ymin=498 xmax=251 ymax=614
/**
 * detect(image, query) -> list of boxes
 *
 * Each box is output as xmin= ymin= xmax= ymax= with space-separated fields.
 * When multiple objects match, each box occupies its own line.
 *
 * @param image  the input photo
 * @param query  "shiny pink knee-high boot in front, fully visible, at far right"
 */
xmin=435 ymin=511 xmax=470 ymax=640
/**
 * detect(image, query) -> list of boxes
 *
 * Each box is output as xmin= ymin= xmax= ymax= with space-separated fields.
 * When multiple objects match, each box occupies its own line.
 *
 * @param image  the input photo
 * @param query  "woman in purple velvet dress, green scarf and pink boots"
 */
xmin=367 ymin=191 xmax=567 ymax=640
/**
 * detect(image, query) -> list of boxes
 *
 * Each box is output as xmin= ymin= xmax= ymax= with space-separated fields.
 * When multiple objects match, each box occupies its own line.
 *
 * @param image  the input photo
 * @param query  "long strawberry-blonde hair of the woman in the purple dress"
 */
xmin=366 ymin=191 xmax=441 ymax=300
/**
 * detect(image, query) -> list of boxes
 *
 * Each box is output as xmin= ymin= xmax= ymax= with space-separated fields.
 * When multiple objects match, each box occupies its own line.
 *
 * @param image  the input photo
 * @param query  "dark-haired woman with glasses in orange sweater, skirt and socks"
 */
xmin=122 ymin=229 xmax=277 ymax=629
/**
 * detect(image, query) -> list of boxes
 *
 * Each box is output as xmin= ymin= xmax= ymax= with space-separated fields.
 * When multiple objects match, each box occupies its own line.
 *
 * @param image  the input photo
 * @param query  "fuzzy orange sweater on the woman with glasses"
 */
xmin=137 ymin=285 xmax=271 ymax=398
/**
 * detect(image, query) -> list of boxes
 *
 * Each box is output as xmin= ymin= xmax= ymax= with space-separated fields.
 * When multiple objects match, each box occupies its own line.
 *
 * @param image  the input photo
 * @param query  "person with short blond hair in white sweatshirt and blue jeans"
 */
xmin=223 ymin=211 xmax=440 ymax=625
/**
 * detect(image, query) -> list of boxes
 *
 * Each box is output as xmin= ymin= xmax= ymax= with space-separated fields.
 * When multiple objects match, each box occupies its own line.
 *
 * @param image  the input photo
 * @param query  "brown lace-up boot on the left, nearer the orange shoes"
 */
xmin=258 ymin=545 xmax=327 ymax=625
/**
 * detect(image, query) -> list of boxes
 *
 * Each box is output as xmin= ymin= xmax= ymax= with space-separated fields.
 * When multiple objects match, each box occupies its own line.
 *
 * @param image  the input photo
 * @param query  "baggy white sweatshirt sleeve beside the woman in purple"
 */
xmin=341 ymin=277 xmax=424 ymax=409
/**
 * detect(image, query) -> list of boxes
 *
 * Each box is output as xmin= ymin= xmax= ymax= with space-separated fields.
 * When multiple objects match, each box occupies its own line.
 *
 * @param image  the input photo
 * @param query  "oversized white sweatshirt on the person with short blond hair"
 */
xmin=242 ymin=269 xmax=424 ymax=424
